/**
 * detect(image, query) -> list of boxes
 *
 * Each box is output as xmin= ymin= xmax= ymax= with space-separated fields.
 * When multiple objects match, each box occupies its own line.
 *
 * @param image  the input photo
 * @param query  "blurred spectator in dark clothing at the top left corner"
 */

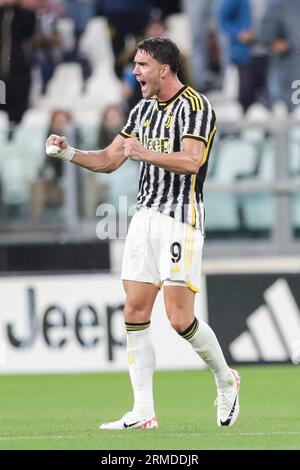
xmin=0 ymin=0 xmax=36 ymax=123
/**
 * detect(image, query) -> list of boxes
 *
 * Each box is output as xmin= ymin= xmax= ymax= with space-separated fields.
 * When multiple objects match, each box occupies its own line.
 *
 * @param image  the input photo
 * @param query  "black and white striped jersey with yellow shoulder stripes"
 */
xmin=120 ymin=86 xmax=216 ymax=232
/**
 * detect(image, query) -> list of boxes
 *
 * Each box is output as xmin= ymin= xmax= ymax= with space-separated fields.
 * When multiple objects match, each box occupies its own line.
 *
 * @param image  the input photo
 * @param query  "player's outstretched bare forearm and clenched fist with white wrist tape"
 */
xmin=46 ymin=134 xmax=127 ymax=173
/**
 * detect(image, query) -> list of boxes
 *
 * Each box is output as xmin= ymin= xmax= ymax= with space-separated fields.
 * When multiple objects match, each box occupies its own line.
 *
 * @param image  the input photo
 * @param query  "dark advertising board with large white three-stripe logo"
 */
xmin=208 ymin=274 xmax=300 ymax=364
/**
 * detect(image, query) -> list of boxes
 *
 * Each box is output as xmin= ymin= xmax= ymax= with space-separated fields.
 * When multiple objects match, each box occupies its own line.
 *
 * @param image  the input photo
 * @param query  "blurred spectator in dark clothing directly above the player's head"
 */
xmin=100 ymin=0 xmax=152 ymax=78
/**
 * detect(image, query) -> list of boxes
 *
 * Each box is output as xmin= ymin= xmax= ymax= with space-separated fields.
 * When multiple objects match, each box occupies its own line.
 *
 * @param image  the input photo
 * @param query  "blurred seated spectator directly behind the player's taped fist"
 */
xmin=31 ymin=109 xmax=79 ymax=219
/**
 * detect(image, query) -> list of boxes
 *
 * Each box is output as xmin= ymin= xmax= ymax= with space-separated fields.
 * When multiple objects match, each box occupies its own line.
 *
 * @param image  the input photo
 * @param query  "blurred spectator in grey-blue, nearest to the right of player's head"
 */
xmin=183 ymin=0 xmax=223 ymax=92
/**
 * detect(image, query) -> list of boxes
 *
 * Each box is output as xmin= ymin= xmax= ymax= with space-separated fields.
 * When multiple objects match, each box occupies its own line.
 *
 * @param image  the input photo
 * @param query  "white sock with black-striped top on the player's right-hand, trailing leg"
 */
xmin=181 ymin=318 xmax=234 ymax=388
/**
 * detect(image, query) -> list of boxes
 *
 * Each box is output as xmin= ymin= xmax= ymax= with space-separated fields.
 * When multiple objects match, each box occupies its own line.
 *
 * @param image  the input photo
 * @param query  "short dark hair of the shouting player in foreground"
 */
xmin=137 ymin=37 xmax=180 ymax=73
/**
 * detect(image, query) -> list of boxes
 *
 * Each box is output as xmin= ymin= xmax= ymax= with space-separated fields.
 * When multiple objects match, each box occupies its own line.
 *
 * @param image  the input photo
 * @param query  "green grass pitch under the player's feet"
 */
xmin=0 ymin=366 xmax=300 ymax=450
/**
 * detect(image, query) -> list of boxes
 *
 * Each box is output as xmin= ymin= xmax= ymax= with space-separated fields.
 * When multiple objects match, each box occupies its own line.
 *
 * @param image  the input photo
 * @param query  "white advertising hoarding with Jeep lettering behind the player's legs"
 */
xmin=0 ymin=274 xmax=207 ymax=373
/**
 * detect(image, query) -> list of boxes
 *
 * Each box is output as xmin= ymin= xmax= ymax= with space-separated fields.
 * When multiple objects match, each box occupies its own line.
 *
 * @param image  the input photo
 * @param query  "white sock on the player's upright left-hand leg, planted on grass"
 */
xmin=125 ymin=322 xmax=155 ymax=418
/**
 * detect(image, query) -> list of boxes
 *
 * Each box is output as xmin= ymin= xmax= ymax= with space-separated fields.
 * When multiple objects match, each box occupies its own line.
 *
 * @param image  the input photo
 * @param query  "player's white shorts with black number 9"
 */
xmin=122 ymin=207 xmax=204 ymax=292
